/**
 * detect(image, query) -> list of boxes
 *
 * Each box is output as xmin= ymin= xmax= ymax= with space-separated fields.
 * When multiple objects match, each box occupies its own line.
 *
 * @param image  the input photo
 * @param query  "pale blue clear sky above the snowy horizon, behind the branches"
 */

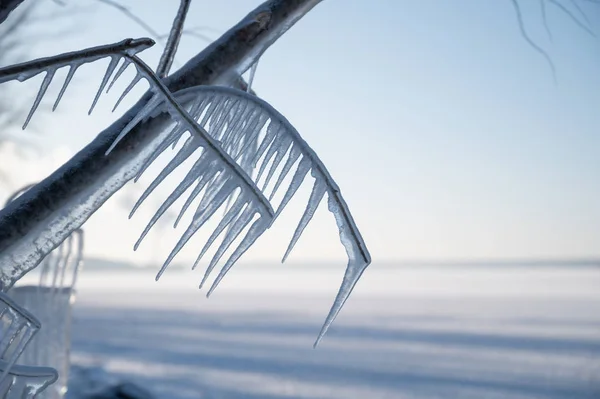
xmin=0 ymin=0 xmax=600 ymax=268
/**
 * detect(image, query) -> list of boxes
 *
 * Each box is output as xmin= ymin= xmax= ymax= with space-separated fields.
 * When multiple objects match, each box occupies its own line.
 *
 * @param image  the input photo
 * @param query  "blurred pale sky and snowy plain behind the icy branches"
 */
xmin=0 ymin=0 xmax=600 ymax=399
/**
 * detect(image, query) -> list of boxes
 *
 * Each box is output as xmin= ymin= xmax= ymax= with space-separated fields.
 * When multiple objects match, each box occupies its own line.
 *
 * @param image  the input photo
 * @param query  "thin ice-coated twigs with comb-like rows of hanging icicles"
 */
xmin=0 ymin=39 xmax=371 ymax=344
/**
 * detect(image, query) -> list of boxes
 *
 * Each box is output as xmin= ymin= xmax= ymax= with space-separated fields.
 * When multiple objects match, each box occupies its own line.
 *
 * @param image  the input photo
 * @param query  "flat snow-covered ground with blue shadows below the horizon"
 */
xmin=58 ymin=265 xmax=600 ymax=399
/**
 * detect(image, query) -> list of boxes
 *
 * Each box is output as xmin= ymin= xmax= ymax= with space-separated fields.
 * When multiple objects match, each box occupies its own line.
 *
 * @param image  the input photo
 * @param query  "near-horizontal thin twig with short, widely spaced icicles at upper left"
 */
xmin=0 ymin=38 xmax=154 ymax=129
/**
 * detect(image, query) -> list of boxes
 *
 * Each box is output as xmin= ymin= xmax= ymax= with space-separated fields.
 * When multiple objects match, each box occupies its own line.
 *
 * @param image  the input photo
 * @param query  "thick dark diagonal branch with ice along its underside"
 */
xmin=0 ymin=0 xmax=320 ymax=290
